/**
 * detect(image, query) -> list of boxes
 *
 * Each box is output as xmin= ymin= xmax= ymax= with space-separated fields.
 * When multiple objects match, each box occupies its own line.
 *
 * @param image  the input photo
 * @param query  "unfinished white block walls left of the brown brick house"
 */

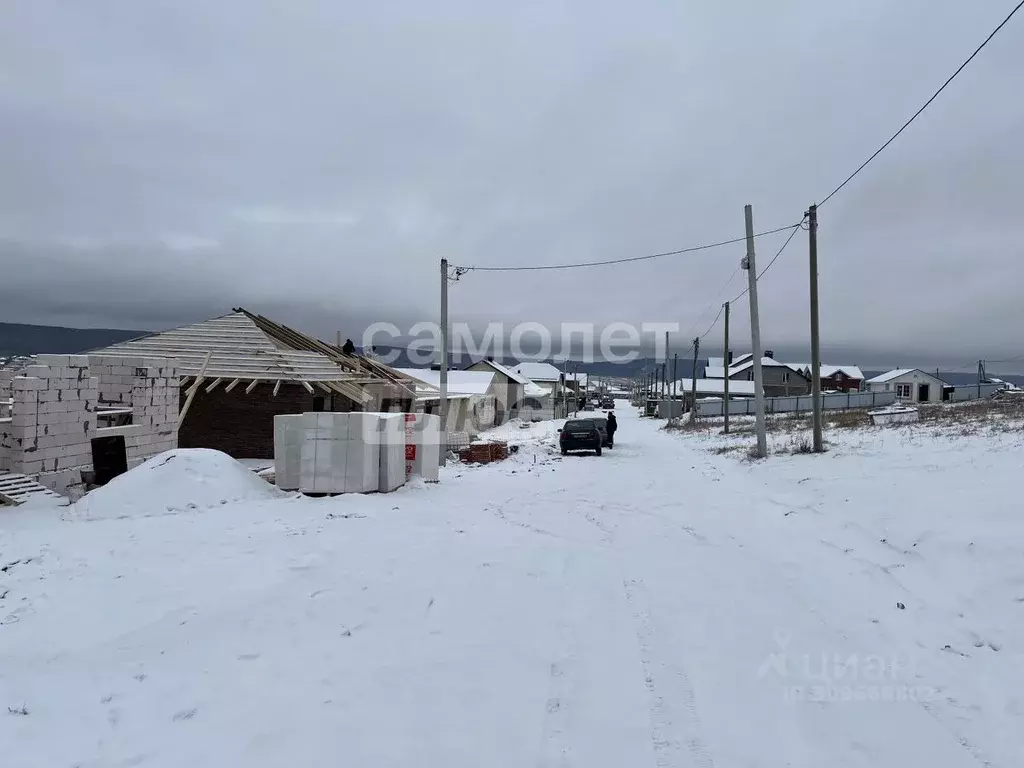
xmin=0 ymin=354 xmax=178 ymax=493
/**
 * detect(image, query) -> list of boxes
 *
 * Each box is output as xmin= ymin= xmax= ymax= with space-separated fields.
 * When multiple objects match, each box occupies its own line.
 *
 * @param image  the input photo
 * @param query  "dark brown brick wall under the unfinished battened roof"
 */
xmin=172 ymin=382 xmax=358 ymax=459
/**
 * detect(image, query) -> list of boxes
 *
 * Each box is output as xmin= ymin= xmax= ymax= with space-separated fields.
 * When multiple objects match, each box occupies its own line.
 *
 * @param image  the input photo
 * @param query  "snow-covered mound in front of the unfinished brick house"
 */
xmin=71 ymin=449 xmax=281 ymax=519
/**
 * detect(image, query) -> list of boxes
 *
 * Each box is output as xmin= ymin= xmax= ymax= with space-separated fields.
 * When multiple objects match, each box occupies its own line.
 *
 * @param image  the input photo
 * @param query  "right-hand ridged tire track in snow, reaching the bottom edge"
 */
xmin=623 ymin=579 xmax=715 ymax=768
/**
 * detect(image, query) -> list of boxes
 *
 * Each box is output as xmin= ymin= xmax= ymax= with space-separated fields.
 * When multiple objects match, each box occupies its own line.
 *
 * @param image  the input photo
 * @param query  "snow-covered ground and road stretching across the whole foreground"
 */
xmin=0 ymin=403 xmax=1024 ymax=768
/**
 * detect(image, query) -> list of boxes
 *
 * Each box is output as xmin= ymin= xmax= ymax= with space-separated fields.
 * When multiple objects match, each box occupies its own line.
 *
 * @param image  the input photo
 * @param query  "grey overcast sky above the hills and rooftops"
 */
xmin=0 ymin=0 xmax=1024 ymax=366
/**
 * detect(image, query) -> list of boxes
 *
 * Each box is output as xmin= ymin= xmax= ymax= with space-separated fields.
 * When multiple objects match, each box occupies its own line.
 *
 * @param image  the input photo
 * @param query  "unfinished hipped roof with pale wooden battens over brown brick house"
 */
xmin=91 ymin=309 xmax=413 ymax=400
